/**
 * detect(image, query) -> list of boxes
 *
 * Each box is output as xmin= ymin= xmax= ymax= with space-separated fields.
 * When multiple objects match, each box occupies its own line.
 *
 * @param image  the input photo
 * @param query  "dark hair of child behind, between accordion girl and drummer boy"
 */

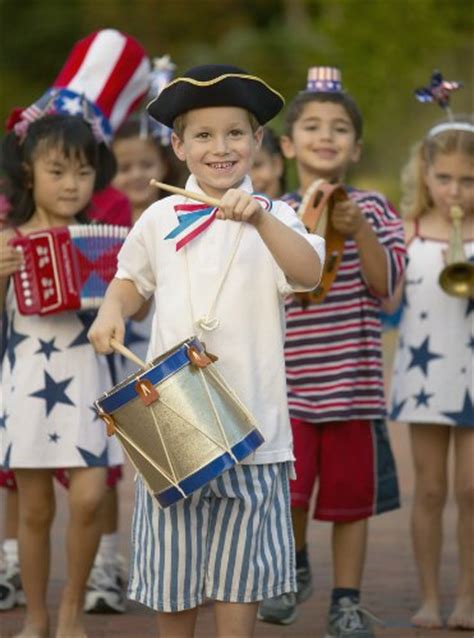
xmin=112 ymin=113 xmax=185 ymax=194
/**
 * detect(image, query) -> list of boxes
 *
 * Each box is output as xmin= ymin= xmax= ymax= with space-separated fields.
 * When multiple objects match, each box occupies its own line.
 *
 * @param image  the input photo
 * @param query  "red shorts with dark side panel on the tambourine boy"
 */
xmin=290 ymin=419 xmax=400 ymax=522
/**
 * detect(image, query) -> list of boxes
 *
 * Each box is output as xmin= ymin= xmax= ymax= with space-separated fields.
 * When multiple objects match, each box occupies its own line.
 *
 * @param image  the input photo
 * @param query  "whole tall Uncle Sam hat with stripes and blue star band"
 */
xmin=7 ymin=29 xmax=150 ymax=143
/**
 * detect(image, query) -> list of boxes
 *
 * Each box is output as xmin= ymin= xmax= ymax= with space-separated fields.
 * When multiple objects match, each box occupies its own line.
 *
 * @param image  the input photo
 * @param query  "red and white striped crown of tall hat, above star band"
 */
xmin=52 ymin=29 xmax=151 ymax=131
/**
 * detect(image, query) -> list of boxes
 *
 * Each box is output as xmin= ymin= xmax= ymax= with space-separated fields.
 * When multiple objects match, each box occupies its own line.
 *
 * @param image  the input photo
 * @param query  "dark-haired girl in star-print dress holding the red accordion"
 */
xmin=0 ymin=114 xmax=122 ymax=638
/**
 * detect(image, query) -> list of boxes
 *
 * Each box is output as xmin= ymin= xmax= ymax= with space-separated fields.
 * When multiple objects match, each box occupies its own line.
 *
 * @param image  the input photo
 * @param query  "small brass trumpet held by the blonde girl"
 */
xmin=438 ymin=206 xmax=474 ymax=297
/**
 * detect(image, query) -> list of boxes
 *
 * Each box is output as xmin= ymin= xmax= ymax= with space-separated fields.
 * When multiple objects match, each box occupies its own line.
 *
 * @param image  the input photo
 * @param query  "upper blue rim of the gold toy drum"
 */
xmin=95 ymin=337 xmax=204 ymax=414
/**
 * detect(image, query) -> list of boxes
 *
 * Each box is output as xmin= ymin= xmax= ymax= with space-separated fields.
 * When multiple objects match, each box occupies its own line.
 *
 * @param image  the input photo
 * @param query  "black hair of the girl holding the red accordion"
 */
xmin=0 ymin=114 xmax=116 ymax=226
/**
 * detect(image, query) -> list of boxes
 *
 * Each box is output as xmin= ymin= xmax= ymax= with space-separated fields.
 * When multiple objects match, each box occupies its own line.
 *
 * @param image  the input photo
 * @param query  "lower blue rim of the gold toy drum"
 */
xmin=154 ymin=429 xmax=264 ymax=507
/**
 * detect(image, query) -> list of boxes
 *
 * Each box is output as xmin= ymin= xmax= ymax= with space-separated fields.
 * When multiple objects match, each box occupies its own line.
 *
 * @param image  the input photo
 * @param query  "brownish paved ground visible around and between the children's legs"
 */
xmin=0 ymin=332 xmax=462 ymax=638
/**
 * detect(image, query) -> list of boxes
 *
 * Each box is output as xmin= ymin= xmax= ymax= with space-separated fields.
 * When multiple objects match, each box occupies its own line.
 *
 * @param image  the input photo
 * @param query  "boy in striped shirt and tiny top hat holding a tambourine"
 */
xmin=259 ymin=67 xmax=406 ymax=638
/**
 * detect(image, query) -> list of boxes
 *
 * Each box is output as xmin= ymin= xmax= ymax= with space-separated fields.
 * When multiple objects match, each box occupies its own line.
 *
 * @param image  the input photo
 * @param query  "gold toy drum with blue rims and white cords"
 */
xmin=95 ymin=337 xmax=263 ymax=507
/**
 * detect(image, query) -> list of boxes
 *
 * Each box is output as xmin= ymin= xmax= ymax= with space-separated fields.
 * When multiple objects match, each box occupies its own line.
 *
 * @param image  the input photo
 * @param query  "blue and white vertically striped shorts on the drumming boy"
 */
xmin=128 ymin=463 xmax=296 ymax=612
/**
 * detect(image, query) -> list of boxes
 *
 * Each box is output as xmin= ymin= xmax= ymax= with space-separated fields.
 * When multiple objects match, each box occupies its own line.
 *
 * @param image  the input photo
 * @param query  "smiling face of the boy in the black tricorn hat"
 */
xmin=172 ymin=106 xmax=262 ymax=198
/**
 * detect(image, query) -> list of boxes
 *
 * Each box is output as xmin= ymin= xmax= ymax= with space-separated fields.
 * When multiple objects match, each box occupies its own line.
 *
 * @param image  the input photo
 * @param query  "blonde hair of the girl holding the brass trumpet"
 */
xmin=400 ymin=115 xmax=474 ymax=219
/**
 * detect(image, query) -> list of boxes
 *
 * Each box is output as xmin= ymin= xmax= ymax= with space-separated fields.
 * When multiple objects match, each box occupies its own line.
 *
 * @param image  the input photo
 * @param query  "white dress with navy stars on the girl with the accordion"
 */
xmin=0 ymin=286 xmax=123 ymax=469
